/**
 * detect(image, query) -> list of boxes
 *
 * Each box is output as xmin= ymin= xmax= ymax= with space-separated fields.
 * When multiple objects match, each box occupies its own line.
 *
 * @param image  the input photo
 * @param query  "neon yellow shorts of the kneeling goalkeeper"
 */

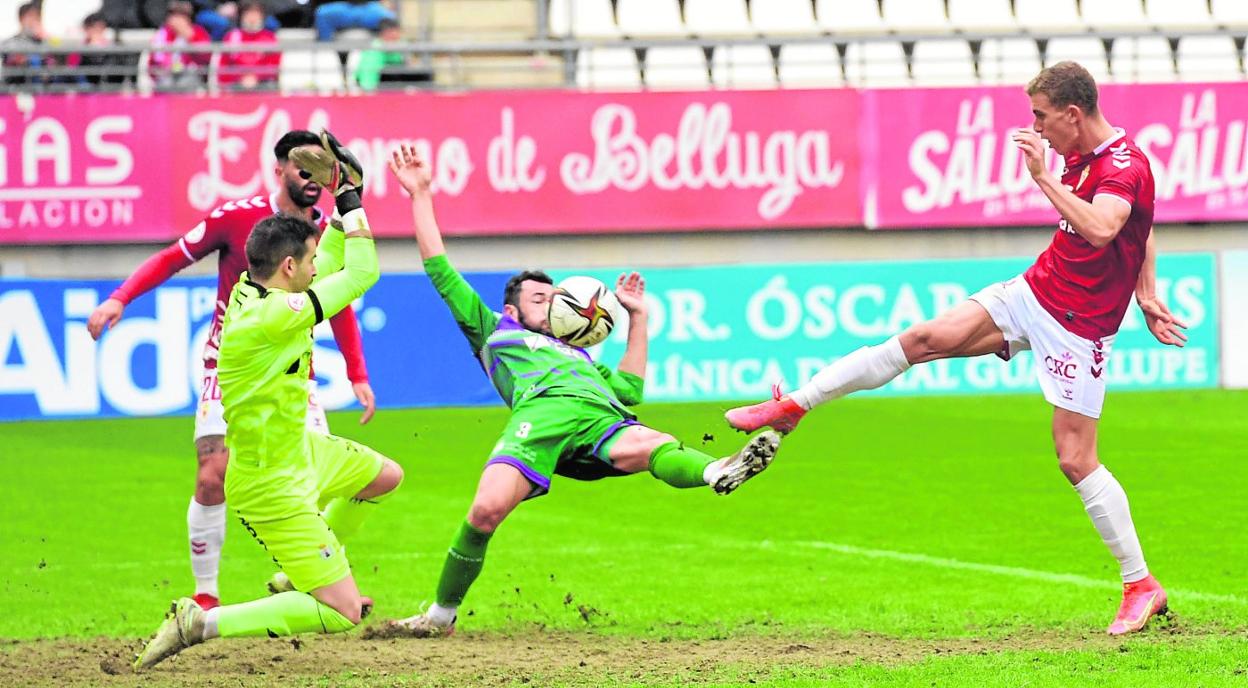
xmin=226 ymin=432 xmax=386 ymax=592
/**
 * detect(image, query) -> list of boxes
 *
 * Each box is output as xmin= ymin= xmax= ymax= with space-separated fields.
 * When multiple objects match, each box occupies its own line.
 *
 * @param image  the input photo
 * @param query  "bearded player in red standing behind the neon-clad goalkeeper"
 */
xmin=87 ymin=130 xmax=376 ymax=609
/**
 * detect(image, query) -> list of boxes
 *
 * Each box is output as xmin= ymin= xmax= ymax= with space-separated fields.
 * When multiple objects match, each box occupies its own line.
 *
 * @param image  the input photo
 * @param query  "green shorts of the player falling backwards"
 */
xmin=485 ymin=395 xmax=639 ymax=498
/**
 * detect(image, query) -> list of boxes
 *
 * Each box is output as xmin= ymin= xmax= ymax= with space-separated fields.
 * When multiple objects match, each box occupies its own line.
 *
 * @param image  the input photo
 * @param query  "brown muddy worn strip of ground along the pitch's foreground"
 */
xmin=0 ymin=629 xmax=1228 ymax=687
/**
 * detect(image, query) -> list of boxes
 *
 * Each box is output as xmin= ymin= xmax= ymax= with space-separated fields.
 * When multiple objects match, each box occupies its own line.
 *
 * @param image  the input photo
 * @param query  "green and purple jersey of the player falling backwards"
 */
xmin=424 ymin=255 xmax=645 ymax=417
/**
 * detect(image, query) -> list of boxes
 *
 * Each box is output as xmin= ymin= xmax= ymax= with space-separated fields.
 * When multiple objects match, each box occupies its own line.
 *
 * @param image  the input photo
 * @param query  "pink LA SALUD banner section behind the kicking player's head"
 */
xmin=861 ymin=84 xmax=1248 ymax=229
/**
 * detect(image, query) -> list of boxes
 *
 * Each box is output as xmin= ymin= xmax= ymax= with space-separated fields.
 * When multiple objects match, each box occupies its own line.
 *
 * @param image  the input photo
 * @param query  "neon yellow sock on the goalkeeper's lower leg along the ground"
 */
xmin=217 ymin=592 xmax=356 ymax=638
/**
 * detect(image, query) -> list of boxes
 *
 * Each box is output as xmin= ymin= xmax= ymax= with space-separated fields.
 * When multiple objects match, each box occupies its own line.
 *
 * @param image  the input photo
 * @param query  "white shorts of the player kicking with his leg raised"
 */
xmin=971 ymin=277 xmax=1113 ymax=418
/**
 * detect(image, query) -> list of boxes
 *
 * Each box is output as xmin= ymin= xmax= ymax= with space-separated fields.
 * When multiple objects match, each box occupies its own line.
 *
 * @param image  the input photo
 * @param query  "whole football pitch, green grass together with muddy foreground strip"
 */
xmin=0 ymin=391 xmax=1248 ymax=687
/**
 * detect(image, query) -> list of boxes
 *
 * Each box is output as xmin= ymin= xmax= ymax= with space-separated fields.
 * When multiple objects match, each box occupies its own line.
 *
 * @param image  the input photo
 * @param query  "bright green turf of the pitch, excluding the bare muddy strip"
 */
xmin=0 ymin=391 xmax=1248 ymax=684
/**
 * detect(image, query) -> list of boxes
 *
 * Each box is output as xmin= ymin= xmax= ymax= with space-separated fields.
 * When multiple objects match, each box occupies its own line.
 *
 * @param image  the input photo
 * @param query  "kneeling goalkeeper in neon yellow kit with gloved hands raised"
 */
xmin=135 ymin=132 xmax=403 ymax=669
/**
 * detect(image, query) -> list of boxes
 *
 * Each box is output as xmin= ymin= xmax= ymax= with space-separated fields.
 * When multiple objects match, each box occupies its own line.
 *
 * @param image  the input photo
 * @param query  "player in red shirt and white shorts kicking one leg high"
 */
xmin=726 ymin=62 xmax=1186 ymax=636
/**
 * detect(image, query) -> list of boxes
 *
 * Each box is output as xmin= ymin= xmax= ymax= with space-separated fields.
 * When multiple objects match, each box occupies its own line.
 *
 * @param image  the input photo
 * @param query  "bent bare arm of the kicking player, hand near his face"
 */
xmin=1013 ymin=129 xmax=1131 ymax=248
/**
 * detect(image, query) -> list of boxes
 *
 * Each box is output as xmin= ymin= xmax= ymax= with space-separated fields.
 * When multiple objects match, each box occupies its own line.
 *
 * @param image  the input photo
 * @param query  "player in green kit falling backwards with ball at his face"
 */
xmin=366 ymin=146 xmax=780 ymax=638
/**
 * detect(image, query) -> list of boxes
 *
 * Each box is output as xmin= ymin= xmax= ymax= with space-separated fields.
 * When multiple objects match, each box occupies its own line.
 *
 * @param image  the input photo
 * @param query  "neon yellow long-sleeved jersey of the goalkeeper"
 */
xmin=217 ymin=219 xmax=378 ymax=484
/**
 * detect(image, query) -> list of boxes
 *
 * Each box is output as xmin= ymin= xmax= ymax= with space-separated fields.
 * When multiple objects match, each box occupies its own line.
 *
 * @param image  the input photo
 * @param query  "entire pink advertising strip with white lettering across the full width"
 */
xmin=0 ymin=84 xmax=1248 ymax=243
